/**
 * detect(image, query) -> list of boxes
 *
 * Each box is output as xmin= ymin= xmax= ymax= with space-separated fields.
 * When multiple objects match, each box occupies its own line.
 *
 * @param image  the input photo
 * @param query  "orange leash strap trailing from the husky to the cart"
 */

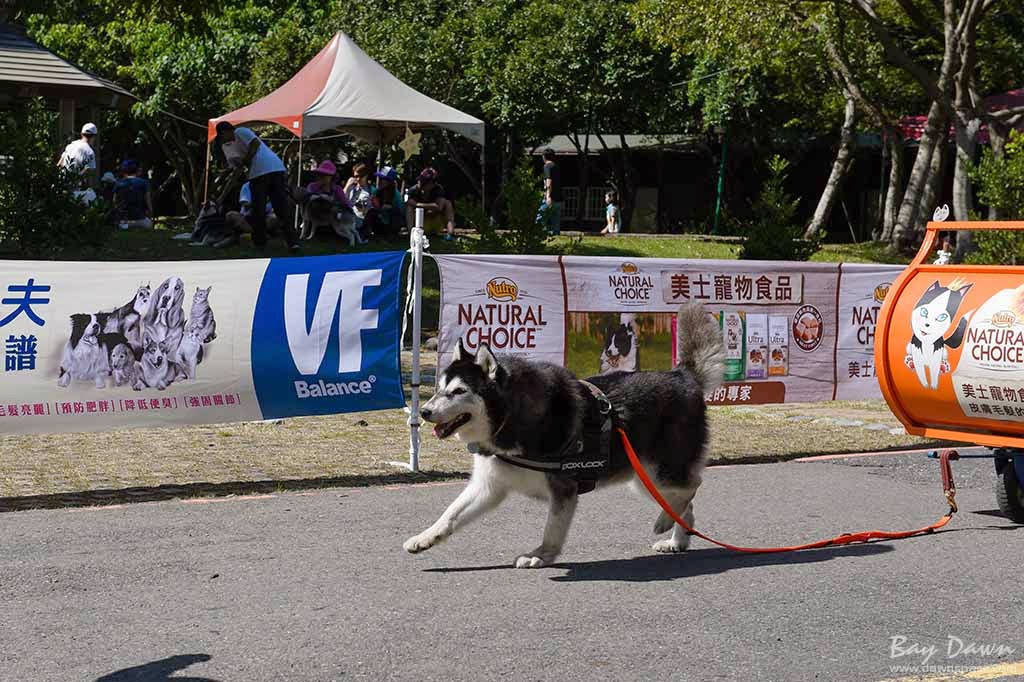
xmin=616 ymin=427 xmax=959 ymax=554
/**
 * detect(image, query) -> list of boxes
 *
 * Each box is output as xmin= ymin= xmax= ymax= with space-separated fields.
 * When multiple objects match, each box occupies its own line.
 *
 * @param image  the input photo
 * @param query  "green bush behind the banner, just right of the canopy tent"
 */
xmin=459 ymin=159 xmax=552 ymax=254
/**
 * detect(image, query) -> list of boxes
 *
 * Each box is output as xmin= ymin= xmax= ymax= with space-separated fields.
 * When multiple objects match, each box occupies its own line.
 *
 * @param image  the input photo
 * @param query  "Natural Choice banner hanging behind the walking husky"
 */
xmin=437 ymin=256 xmax=902 ymax=404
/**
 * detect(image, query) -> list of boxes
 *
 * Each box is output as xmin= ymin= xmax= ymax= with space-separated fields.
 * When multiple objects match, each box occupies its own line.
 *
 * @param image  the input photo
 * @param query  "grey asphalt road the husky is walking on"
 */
xmin=0 ymin=448 xmax=1024 ymax=682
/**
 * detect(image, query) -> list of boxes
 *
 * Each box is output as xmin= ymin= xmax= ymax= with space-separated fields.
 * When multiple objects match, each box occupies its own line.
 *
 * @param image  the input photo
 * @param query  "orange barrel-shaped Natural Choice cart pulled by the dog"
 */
xmin=874 ymin=222 xmax=1024 ymax=523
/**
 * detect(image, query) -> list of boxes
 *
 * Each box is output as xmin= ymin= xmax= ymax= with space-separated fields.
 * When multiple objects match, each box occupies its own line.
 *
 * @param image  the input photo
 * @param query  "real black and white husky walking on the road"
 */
xmin=403 ymin=304 xmax=723 ymax=568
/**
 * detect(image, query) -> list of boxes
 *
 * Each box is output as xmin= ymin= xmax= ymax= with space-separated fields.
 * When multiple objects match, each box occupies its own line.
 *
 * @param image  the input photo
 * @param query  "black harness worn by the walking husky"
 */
xmin=490 ymin=379 xmax=613 ymax=495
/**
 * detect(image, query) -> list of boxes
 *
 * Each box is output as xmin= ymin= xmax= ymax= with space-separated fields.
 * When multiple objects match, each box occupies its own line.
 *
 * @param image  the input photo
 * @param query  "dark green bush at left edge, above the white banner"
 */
xmin=0 ymin=100 xmax=111 ymax=258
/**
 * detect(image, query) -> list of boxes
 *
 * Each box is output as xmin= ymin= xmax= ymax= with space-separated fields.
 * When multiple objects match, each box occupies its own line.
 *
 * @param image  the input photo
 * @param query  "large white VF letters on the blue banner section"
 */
xmin=284 ymin=269 xmax=382 ymax=375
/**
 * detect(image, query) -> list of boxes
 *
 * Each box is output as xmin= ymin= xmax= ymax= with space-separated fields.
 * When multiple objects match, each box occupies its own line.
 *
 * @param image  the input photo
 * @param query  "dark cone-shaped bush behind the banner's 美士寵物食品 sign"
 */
xmin=739 ymin=156 xmax=821 ymax=260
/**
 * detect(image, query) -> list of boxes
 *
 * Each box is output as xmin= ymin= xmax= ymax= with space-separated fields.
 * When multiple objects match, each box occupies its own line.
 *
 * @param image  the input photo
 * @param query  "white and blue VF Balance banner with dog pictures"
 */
xmin=0 ymin=252 xmax=404 ymax=433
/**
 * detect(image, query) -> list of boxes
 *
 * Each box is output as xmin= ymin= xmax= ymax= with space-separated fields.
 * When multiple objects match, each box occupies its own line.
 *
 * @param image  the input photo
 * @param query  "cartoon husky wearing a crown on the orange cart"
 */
xmin=906 ymin=278 xmax=973 ymax=388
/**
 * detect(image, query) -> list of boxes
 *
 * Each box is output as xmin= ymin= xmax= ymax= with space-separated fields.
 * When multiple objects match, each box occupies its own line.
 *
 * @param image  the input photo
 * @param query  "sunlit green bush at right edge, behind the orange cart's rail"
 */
xmin=967 ymin=131 xmax=1024 ymax=265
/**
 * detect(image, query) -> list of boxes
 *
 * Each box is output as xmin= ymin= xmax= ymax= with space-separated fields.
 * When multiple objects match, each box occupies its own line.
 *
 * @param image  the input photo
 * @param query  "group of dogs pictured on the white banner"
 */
xmin=57 ymin=276 xmax=217 ymax=391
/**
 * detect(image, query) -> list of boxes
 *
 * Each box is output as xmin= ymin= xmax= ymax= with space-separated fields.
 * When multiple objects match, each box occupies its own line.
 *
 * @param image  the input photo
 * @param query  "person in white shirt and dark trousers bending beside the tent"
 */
xmin=217 ymin=121 xmax=299 ymax=250
